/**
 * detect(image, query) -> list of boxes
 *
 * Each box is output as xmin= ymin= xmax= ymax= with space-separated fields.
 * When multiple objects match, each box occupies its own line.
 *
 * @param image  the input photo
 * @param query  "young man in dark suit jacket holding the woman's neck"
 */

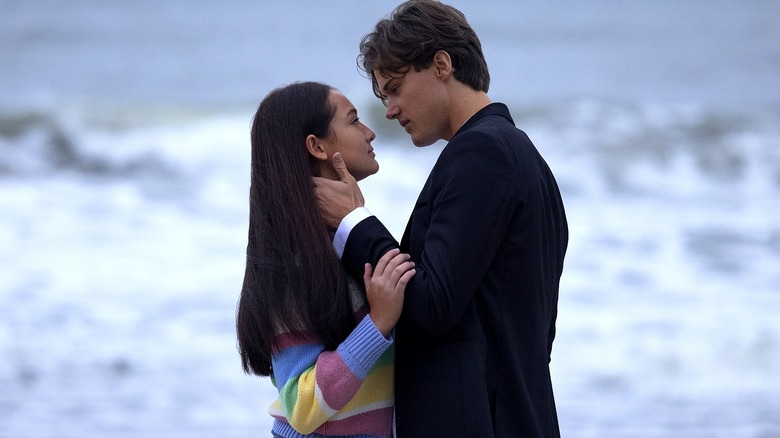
xmin=315 ymin=0 xmax=568 ymax=438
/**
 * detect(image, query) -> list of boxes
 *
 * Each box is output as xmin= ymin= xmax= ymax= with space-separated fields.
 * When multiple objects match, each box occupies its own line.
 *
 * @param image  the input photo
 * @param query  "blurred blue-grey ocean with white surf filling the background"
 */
xmin=0 ymin=0 xmax=780 ymax=438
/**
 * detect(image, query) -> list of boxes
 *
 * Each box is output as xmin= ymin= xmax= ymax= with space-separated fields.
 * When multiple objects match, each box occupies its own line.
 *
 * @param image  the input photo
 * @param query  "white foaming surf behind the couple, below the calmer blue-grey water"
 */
xmin=0 ymin=100 xmax=780 ymax=436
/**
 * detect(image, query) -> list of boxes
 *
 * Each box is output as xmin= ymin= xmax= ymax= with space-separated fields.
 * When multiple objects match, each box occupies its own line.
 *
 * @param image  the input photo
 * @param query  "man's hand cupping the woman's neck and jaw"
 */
xmin=314 ymin=152 xmax=365 ymax=230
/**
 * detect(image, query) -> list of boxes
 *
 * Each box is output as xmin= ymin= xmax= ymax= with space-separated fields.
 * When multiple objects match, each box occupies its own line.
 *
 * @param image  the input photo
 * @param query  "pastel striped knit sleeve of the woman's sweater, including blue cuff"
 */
xmin=269 ymin=315 xmax=393 ymax=434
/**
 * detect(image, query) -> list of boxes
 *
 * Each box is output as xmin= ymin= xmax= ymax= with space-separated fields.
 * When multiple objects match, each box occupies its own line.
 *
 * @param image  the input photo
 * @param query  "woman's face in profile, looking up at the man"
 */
xmin=320 ymin=90 xmax=379 ymax=181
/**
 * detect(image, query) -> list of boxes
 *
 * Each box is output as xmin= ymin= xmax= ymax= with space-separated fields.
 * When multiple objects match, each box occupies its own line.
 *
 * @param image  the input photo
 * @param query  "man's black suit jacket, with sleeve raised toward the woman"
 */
xmin=342 ymin=103 xmax=568 ymax=438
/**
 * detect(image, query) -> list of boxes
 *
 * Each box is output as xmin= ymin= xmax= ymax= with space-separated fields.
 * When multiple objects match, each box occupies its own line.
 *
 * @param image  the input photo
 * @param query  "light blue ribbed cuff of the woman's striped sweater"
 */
xmin=338 ymin=315 xmax=393 ymax=380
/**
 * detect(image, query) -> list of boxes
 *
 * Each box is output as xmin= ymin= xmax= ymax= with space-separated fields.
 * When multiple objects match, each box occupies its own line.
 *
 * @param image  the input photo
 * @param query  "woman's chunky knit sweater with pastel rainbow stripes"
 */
xmin=268 ymin=305 xmax=394 ymax=438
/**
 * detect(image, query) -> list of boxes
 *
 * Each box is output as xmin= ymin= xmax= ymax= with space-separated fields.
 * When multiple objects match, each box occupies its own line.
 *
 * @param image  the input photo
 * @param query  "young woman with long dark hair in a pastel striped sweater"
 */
xmin=236 ymin=82 xmax=415 ymax=437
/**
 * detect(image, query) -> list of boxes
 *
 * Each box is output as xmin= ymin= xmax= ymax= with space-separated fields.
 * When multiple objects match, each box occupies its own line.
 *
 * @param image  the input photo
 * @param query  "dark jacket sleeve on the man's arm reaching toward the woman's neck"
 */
xmin=342 ymin=133 xmax=517 ymax=335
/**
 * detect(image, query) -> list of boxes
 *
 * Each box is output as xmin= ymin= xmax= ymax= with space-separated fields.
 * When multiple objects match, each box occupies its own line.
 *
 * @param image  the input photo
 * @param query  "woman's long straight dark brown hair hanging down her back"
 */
xmin=236 ymin=82 xmax=355 ymax=376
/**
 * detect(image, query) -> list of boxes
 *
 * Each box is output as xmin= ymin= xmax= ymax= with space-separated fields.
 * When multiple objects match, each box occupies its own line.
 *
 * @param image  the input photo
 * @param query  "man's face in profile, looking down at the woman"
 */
xmin=373 ymin=67 xmax=452 ymax=146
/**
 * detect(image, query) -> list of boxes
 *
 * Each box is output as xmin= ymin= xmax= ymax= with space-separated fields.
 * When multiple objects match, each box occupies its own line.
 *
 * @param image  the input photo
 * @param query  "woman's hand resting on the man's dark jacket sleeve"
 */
xmin=363 ymin=248 xmax=415 ymax=337
